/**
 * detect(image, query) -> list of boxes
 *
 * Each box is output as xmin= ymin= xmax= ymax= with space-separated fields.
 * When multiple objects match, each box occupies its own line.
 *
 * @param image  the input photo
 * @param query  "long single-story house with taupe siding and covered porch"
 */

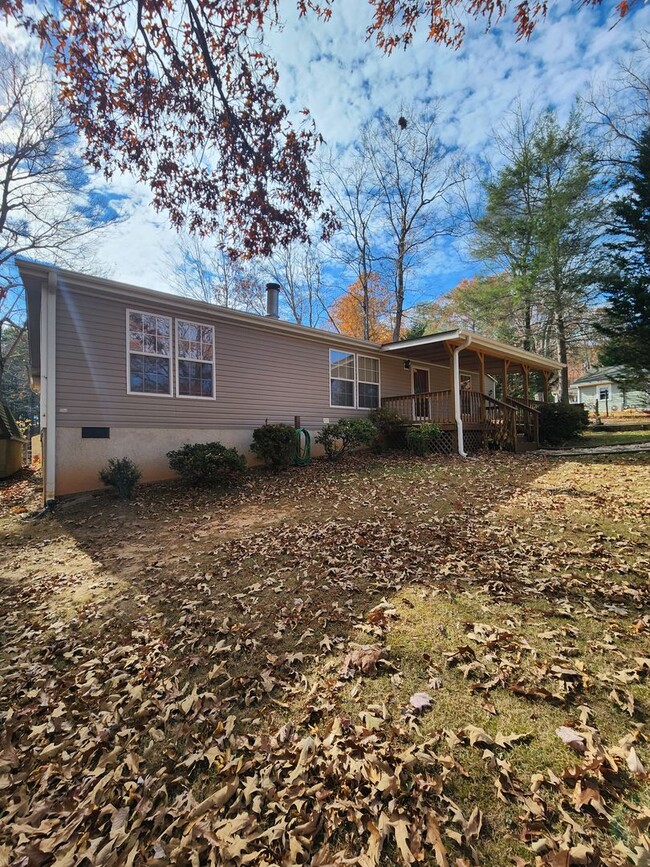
xmin=18 ymin=260 xmax=561 ymax=500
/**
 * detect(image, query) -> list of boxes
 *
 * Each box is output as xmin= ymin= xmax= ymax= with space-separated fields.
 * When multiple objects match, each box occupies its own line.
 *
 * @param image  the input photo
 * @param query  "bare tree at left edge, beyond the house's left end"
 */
xmin=0 ymin=45 xmax=118 ymax=388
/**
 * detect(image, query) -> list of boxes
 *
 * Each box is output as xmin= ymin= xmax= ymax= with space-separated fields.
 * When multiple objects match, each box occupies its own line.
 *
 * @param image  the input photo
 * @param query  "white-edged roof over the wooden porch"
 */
xmin=381 ymin=328 xmax=564 ymax=373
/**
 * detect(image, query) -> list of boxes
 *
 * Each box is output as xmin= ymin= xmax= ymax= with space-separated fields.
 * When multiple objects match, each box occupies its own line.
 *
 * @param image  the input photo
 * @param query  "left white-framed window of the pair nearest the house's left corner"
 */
xmin=127 ymin=310 xmax=172 ymax=395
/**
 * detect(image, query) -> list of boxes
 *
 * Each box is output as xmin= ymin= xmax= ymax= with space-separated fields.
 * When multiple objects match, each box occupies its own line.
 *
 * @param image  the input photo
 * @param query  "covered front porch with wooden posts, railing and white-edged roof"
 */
xmin=382 ymin=329 xmax=562 ymax=454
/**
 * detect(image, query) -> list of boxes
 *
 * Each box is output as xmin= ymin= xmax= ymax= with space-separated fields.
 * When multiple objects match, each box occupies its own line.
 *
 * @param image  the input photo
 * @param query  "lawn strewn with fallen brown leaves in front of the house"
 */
xmin=0 ymin=454 xmax=650 ymax=867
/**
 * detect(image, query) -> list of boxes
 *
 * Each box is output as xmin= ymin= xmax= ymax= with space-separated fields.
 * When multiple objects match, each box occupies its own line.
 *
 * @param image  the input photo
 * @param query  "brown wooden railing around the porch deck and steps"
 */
xmin=381 ymin=390 xmax=539 ymax=451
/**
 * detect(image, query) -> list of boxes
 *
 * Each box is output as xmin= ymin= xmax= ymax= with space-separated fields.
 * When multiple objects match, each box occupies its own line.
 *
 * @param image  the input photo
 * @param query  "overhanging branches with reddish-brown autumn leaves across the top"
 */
xmin=3 ymin=0 xmax=628 ymax=255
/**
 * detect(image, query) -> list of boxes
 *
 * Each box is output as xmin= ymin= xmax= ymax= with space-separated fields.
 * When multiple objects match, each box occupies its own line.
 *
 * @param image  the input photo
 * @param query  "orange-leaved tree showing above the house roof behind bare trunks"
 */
xmin=330 ymin=271 xmax=393 ymax=343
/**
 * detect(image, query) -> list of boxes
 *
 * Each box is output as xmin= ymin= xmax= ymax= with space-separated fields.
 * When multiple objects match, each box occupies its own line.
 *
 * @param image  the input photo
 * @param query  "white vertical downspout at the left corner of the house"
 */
xmin=41 ymin=271 xmax=57 ymax=505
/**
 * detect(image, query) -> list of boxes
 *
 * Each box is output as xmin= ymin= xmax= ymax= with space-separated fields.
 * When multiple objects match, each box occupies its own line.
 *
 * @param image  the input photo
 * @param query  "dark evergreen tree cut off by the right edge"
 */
xmin=598 ymin=127 xmax=650 ymax=381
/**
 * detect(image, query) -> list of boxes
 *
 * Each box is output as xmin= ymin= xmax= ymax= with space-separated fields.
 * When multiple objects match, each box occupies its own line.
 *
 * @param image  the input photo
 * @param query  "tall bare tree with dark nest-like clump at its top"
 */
xmin=363 ymin=106 xmax=467 ymax=340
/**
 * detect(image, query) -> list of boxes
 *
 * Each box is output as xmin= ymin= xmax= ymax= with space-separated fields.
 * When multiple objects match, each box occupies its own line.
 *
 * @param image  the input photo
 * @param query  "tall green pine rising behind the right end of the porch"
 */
xmin=473 ymin=109 xmax=604 ymax=401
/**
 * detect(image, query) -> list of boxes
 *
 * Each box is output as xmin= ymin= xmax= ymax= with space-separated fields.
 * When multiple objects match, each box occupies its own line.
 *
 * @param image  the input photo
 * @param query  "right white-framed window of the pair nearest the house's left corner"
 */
xmin=176 ymin=319 xmax=214 ymax=398
